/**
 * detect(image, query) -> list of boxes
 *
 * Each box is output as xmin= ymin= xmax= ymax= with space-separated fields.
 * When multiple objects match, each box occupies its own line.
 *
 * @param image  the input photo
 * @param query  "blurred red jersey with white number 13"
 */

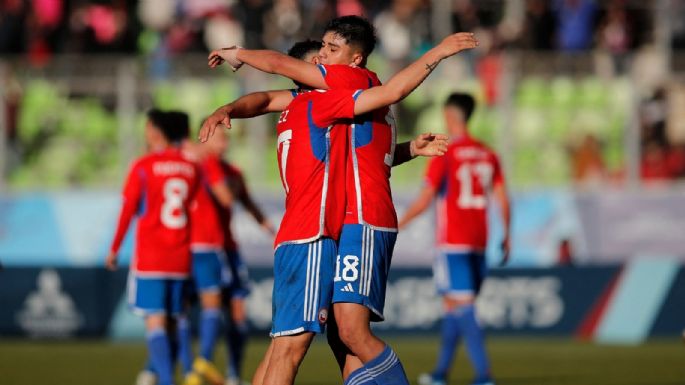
xmin=426 ymin=136 xmax=504 ymax=251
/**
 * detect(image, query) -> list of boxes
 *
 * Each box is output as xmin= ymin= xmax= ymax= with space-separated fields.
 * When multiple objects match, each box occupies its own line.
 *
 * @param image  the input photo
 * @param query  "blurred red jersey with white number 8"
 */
xmin=111 ymin=148 xmax=199 ymax=278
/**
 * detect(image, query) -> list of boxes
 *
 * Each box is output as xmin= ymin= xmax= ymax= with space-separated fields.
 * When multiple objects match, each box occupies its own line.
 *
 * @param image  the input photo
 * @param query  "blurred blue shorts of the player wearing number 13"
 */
xmin=433 ymin=252 xmax=487 ymax=297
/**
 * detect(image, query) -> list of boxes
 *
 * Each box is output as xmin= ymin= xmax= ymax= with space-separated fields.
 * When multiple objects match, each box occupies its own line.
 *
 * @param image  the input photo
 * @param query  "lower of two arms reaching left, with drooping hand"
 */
xmin=198 ymin=90 xmax=293 ymax=142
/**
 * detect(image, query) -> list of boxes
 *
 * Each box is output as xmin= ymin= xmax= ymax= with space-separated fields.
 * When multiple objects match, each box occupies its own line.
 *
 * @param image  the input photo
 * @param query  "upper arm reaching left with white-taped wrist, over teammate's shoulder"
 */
xmin=207 ymin=47 xmax=328 ymax=89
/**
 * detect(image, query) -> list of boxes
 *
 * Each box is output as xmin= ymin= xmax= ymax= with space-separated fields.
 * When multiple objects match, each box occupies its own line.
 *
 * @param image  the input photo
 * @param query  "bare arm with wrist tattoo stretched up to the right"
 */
xmin=354 ymin=32 xmax=478 ymax=115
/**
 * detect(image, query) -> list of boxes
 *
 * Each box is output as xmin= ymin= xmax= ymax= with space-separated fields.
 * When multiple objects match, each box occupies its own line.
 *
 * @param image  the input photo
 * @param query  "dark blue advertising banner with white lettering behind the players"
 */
xmin=0 ymin=265 xmax=685 ymax=338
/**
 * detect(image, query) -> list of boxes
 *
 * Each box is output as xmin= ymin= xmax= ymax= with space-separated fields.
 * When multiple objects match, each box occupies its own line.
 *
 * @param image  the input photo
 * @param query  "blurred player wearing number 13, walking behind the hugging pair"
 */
xmin=400 ymin=93 xmax=511 ymax=385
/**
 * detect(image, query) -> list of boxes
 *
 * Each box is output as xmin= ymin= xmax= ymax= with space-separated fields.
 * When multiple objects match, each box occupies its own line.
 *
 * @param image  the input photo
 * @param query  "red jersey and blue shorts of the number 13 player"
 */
xmin=426 ymin=136 xmax=504 ymax=296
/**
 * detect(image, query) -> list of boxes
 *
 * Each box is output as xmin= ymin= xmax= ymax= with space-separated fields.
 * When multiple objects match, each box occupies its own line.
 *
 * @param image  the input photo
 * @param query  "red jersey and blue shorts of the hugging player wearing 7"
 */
xmin=271 ymin=90 xmax=355 ymax=336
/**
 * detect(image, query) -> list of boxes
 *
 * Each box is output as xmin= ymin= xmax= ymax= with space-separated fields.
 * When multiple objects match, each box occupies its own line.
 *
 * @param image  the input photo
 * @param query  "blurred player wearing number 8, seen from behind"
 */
xmin=105 ymin=109 xmax=199 ymax=385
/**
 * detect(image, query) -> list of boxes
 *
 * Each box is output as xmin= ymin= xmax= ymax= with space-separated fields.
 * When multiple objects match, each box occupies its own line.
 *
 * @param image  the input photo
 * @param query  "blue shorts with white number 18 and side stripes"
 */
xmin=333 ymin=225 xmax=397 ymax=321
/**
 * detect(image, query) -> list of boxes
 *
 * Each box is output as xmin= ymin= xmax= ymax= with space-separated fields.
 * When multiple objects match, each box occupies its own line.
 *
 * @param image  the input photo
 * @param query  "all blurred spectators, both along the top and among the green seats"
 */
xmin=0 ymin=0 xmax=685 ymax=181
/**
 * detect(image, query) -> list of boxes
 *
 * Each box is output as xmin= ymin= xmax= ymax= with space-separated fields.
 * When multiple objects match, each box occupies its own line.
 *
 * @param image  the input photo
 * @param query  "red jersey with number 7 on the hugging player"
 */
xmin=275 ymin=90 xmax=355 ymax=247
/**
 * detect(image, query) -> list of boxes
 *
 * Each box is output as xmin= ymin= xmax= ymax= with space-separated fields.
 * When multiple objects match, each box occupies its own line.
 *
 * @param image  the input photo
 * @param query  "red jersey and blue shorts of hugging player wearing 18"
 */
xmin=319 ymin=65 xmax=397 ymax=321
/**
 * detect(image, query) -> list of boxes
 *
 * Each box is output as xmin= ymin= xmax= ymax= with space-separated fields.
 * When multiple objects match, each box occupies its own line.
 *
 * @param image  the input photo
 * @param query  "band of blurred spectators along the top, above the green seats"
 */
xmin=0 ymin=0 xmax=652 ymax=63
